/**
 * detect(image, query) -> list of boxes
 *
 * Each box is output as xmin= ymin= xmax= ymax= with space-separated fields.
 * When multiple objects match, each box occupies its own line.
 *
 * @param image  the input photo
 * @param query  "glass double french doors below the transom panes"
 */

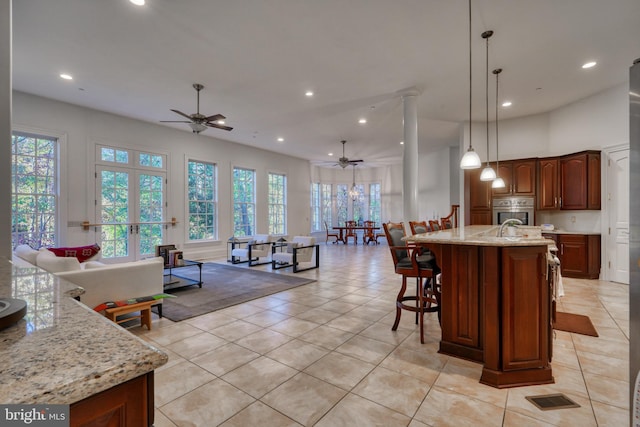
xmin=96 ymin=165 xmax=166 ymax=262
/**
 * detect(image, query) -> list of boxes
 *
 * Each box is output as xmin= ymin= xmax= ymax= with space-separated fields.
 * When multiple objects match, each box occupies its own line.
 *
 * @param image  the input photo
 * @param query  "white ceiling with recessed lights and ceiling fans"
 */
xmin=13 ymin=0 xmax=640 ymax=165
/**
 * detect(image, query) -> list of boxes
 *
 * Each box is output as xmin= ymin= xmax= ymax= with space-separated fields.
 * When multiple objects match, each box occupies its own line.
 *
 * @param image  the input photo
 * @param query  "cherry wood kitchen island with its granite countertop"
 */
xmin=405 ymin=225 xmax=554 ymax=388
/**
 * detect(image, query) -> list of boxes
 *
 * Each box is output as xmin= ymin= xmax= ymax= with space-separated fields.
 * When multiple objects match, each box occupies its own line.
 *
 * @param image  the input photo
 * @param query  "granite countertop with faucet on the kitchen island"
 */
xmin=404 ymin=225 xmax=554 ymax=246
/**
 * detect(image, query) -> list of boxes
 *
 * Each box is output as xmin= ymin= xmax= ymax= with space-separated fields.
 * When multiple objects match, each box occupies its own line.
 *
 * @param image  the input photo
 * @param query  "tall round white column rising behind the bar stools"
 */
xmin=402 ymin=90 xmax=419 ymax=222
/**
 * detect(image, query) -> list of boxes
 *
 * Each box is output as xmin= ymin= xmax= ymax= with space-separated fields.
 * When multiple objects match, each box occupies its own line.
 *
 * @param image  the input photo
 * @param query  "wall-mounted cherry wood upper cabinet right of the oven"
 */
xmin=536 ymin=151 xmax=600 ymax=210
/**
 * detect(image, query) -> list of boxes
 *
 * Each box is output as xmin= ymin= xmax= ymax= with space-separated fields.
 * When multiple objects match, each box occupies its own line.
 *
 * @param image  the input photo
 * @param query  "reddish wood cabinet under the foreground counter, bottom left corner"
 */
xmin=69 ymin=371 xmax=154 ymax=427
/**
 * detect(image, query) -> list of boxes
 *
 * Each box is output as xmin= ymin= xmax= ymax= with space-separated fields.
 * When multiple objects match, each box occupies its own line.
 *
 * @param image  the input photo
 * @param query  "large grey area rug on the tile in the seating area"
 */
xmin=162 ymin=263 xmax=315 ymax=322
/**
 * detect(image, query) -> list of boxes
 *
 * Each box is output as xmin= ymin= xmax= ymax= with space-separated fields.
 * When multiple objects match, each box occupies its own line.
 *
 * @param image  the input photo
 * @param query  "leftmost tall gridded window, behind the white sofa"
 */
xmin=11 ymin=133 xmax=59 ymax=248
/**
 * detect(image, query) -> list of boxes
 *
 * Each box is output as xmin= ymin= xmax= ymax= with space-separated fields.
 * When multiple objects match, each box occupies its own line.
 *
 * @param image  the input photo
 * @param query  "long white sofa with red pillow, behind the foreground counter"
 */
xmin=13 ymin=245 xmax=164 ymax=316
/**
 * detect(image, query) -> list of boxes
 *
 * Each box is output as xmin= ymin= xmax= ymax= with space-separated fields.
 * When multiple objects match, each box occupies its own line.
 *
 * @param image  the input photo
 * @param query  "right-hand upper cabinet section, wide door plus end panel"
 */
xmin=560 ymin=151 xmax=600 ymax=210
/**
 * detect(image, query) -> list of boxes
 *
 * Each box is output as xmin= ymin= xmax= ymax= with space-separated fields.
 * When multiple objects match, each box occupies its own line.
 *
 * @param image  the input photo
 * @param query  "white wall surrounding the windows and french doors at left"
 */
xmin=13 ymin=92 xmax=310 ymax=258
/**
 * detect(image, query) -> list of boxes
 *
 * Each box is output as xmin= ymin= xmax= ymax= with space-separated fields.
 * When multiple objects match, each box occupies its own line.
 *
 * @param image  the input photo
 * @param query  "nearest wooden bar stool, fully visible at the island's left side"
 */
xmin=382 ymin=222 xmax=441 ymax=344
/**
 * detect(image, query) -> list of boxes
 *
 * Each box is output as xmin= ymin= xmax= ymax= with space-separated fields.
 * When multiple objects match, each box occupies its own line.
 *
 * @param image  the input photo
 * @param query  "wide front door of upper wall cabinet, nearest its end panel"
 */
xmin=560 ymin=154 xmax=588 ymax=210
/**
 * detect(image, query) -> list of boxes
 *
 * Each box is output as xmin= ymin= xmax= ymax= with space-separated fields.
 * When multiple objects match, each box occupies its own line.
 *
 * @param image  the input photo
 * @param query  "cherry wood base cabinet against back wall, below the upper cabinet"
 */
xmin=544 ymin=233 xmax=600 ymax=279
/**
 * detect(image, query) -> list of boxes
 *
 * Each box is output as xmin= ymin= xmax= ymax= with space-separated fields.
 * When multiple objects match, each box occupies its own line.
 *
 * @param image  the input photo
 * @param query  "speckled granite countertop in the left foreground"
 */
xmin=0 ymin=258 xmax=167 ymax=404
